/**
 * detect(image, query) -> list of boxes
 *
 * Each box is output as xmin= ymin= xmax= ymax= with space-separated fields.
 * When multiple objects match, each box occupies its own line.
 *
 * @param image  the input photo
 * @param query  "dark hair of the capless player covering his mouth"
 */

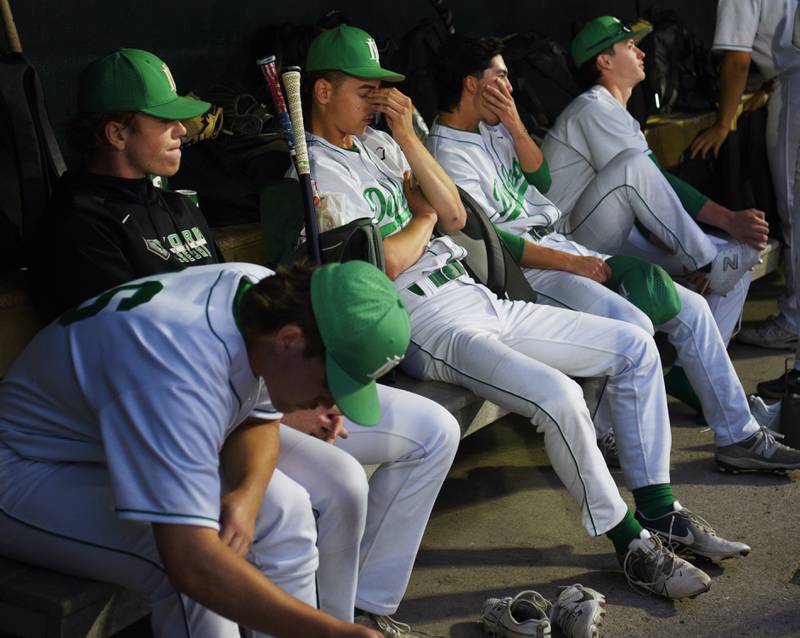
xmin=434 ymin=33 xmax=503 ymax=111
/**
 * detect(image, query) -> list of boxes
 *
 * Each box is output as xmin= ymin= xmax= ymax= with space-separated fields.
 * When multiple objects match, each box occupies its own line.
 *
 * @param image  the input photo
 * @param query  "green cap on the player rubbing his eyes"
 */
xmin=305 ymin=24 xmax=406 ymax=82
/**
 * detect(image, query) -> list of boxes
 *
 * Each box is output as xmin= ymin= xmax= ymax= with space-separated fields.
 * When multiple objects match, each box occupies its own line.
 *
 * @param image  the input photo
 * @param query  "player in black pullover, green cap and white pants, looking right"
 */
xmin=28 ymin=49 xmax=461 ymax=632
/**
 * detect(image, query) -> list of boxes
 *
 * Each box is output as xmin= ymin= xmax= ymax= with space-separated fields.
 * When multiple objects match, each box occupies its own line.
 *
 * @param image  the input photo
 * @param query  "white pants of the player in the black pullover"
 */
xmin=278 ymin=385 xmax=461 ymax=621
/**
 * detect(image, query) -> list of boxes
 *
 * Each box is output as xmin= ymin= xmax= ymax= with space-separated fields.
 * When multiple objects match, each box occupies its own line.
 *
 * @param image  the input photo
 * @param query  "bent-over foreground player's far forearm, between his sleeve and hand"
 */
xmin=220 ymin=419 xmax=280 ymax=498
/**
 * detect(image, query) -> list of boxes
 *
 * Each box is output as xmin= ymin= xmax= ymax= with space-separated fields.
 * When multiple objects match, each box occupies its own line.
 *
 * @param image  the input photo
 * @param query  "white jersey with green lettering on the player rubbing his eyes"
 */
xmin=308 ymin=127 xmax=467 ymax=290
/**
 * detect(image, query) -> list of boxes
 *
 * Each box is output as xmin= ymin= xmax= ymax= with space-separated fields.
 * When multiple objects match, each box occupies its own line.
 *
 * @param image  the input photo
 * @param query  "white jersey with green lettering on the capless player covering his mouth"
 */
xmin=425 ymin=121 xmax=561 ymax=235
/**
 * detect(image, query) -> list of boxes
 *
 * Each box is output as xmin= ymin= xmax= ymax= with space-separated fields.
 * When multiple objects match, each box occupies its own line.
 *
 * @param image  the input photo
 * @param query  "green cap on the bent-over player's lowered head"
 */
xmin=311 ymin=261 xmax=411 ymax=425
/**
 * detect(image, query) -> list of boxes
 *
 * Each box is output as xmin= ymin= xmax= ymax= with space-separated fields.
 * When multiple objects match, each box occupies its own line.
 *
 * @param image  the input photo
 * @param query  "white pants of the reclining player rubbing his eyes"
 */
xmin=402 ymin=278 xmax=670 ymax=535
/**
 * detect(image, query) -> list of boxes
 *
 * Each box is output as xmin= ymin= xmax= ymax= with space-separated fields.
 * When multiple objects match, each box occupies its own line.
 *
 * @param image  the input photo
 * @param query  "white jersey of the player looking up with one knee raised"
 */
xmin=542 ymin=85 xmax=650 ymax=214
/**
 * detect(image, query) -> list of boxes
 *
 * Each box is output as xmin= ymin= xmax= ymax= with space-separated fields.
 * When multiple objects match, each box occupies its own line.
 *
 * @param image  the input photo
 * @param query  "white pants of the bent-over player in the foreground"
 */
xmin=0 ymin=443 xmax=317 ymax=638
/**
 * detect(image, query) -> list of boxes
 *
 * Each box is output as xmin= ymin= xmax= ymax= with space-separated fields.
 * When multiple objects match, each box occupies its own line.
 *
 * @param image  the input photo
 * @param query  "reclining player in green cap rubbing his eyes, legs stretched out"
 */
xmin=305 ymin=25 xmax=748 ymax=598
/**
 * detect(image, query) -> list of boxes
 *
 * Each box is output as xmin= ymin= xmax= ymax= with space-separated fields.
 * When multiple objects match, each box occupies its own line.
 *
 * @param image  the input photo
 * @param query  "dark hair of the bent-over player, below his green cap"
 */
xmin=239 ymin=263 xmax=325 ymax=358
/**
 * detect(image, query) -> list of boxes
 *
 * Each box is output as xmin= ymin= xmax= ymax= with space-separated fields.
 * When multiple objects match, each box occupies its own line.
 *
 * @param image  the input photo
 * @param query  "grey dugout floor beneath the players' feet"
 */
xmin=115 ymin=274 xmax=800 ymax=638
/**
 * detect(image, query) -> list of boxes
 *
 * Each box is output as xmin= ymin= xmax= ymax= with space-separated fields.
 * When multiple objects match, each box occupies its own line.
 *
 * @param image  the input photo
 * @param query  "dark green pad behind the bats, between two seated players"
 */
xmin=259 ymin=179 xmax=303 ymax=268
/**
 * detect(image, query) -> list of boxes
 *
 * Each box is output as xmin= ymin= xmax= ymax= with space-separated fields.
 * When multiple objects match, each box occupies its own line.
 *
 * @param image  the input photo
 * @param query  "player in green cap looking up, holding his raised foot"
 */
xmin=542 ymin=16 xmax=768 ymax=360
